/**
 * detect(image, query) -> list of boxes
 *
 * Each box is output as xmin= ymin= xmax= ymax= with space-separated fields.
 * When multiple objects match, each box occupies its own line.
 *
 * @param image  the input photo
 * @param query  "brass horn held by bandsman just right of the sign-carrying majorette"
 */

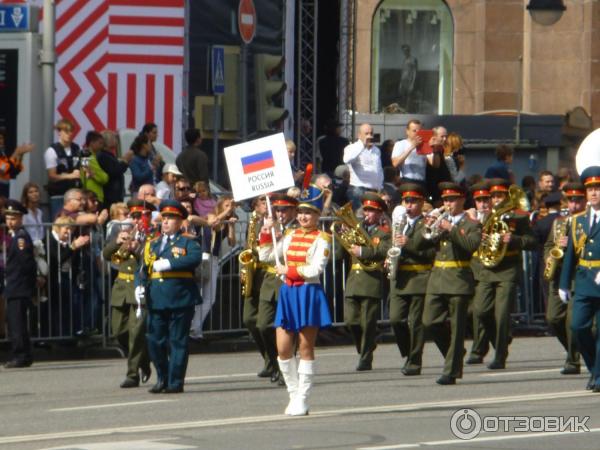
xmin=330 ymin=203 xmax=381 ymax=272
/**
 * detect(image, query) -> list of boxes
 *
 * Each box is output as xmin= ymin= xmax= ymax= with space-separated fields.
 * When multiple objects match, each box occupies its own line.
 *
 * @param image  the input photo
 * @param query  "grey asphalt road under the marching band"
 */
xmin=0 ymin=337 xmax=600 ymax=450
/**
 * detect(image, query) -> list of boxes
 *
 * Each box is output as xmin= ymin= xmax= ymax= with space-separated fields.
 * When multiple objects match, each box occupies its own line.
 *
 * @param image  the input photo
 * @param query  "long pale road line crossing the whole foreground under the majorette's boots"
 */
xmin=0 ymin=391 xmax=596 ymax=444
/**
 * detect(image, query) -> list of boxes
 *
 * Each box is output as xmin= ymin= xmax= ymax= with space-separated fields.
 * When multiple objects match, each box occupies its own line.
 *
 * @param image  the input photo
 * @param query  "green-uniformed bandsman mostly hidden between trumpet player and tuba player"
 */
xmin=467 ymin=181 xmax=490 ymax=364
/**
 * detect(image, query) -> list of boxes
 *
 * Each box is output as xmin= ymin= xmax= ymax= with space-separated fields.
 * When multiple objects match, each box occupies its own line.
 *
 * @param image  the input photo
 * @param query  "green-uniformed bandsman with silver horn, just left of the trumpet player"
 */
xmin=388 ymin=183 xmax=435 ymax=376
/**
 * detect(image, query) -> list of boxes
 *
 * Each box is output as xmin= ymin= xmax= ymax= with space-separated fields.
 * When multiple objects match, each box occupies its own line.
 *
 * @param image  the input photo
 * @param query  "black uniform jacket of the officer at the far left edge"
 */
xmin=4 ymin=228 xmax=37 ymax=299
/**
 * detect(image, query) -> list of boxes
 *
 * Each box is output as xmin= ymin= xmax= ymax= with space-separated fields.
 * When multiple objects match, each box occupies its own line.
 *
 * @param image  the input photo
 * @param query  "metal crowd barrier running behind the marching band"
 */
xmin=0 ymin=217 xmax=545 ymax=346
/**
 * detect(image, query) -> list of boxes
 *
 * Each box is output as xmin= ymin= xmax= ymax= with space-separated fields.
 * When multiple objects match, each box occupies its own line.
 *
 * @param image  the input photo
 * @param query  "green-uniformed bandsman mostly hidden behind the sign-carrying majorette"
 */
xmin=256 ymin=194 xmax=298 ymax=383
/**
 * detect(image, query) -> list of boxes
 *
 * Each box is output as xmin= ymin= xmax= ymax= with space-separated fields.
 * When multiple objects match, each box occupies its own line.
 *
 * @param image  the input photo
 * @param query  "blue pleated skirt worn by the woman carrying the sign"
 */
xmin=275 ymin=283 xmax=331 ymax=332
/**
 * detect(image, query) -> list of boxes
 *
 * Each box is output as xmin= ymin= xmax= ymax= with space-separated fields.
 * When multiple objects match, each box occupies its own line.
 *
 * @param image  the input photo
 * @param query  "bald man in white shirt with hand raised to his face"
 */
xmin=344 ymin=123 xmax=383 ymax=210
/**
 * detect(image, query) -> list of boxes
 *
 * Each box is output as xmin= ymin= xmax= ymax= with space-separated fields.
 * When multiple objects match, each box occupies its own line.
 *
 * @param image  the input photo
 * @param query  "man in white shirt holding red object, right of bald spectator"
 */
xmin=392 ymin=119 xmax=440 ymax=187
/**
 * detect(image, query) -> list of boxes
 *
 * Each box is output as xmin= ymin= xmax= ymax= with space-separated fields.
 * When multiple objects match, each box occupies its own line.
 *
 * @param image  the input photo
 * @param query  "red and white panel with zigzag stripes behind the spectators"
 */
xmin=49 ymin=0 xmax=185 ymax=152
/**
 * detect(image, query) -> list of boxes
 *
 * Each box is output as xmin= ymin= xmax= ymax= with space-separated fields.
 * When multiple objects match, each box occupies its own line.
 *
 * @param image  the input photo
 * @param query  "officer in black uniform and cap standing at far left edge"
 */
xmin=4 ymin=200 xmax=37 ymax=369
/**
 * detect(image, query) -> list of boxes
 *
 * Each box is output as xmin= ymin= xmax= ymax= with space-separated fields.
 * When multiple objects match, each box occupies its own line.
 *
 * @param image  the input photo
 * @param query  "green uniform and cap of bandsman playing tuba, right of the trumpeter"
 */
xmin=473 ymin=179 xmax=537 ymax=369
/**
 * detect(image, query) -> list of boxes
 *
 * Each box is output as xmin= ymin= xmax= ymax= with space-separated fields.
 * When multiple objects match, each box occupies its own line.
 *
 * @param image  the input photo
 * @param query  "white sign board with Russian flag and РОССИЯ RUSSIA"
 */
xmin=225 ymin=133 xmax=294 ymax=201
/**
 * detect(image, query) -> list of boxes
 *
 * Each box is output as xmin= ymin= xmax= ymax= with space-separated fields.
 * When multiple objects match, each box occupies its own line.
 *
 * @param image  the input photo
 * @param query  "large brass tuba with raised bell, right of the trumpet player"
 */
xmin=477 ymin=184 xmax=528 ymax=269
